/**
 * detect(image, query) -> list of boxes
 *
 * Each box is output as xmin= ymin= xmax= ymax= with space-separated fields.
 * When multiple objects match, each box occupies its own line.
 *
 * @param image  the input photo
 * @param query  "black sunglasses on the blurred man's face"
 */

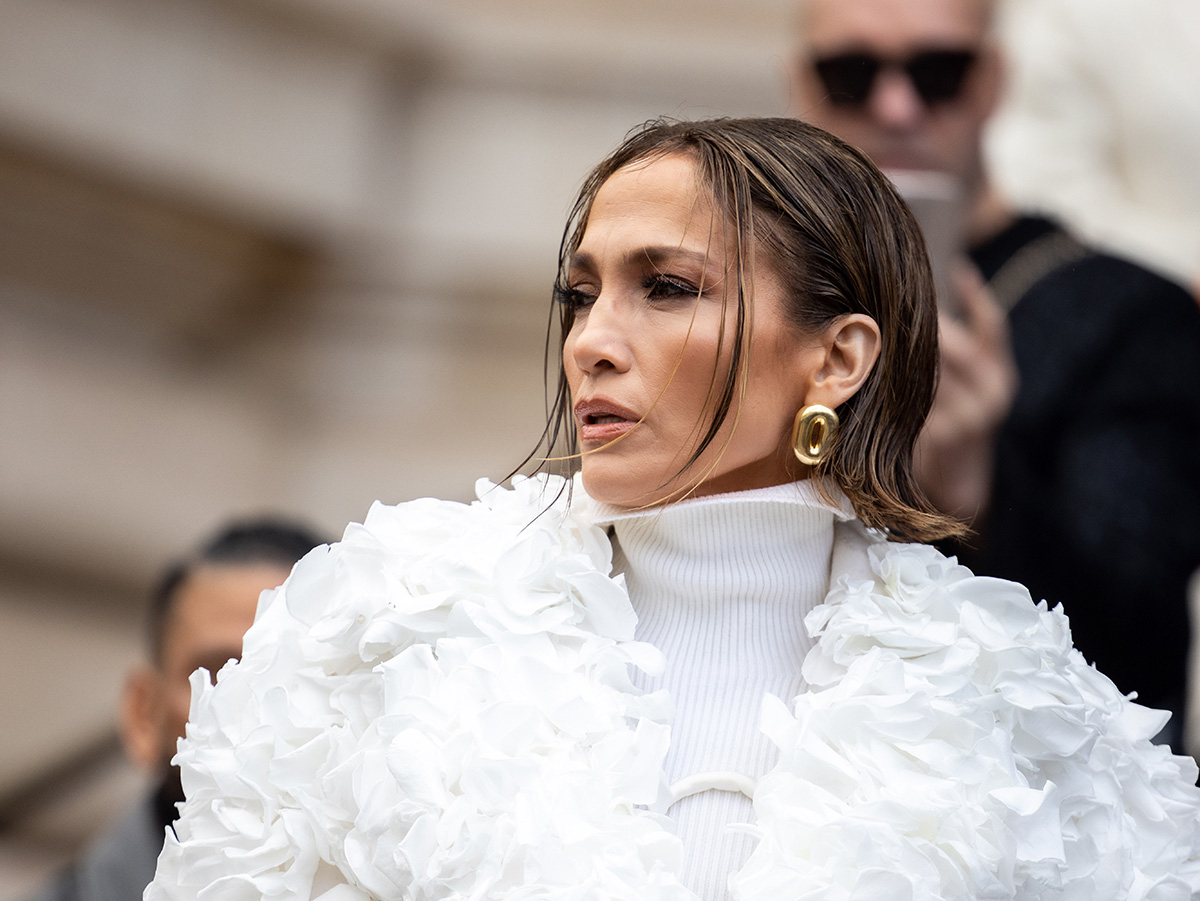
xmin=812 ymin=50 xmax=977 ymax=107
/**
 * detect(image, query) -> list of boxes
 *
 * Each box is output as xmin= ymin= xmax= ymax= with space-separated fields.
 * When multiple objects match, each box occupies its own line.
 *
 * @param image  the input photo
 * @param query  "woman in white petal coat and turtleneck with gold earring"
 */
xmin=146 ymin=120 xmax=1200 ymax=901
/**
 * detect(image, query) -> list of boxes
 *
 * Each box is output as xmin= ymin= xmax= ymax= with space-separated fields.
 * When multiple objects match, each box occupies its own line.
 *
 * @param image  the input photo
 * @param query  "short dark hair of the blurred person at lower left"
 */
xmin=148 ymin=517 xmax=325 ymax=665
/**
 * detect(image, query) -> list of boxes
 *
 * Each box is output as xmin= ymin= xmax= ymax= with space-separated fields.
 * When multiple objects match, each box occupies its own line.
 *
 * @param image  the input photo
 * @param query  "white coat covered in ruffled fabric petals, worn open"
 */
xmin=145 ymin=479 xmax=1200 ymax=901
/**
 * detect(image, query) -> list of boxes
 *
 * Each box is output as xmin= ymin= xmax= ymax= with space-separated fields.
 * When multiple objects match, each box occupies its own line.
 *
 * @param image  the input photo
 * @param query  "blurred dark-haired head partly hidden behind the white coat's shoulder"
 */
xmin=121 ymin=519 xmax=322 ymax=815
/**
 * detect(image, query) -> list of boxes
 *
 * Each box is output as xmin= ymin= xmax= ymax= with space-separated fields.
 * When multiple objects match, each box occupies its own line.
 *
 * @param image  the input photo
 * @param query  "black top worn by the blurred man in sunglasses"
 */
xmin=950 ymin=217 xmax=1200 ymax=748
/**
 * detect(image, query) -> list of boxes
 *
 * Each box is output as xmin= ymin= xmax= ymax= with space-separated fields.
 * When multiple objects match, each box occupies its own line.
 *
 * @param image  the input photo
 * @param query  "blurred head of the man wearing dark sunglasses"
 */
xmin=792 ymin=0 xmax=1002 ymax=197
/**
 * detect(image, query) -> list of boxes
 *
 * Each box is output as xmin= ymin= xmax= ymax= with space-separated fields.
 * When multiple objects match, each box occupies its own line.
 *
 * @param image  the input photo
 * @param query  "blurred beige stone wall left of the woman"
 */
xmin=0 ymin=0 xmax=791 ymax=901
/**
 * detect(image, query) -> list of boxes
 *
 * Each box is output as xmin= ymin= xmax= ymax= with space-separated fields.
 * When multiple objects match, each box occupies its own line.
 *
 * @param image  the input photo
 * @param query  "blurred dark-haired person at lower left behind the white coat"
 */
xmin=37 ymin=519 xmax=322 ymax=901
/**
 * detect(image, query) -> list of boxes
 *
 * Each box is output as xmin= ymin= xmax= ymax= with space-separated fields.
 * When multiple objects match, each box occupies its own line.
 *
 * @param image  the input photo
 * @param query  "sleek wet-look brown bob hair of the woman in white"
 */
xmin=540 ymin=119 xmax=965 ymax=541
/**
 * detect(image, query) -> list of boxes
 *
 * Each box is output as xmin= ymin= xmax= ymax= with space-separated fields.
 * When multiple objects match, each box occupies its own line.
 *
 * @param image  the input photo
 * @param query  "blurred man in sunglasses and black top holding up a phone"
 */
xmin=792 ymin=0 xmax=1200 ymax=750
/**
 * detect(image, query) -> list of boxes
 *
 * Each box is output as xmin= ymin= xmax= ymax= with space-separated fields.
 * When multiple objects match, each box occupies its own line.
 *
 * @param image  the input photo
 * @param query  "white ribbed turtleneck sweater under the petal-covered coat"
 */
xmin=600 ymin=481 xmax=852 ymax=901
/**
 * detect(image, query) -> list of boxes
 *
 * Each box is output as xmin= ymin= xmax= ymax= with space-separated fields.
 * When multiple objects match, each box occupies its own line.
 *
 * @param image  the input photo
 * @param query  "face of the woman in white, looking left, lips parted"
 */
xmin=563 ymin=155 xmax=823 ymax=506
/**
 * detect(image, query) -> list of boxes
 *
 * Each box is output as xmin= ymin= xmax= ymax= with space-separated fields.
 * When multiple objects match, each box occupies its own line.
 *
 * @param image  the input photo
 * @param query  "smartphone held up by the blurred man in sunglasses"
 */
xmin=884 ymin=169 xmax=966 ymax=318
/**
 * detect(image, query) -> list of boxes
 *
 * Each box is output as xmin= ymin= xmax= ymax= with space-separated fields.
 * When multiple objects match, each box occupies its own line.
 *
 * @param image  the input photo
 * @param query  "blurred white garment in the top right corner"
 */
xmin=988 ymin=0 xmax=1200 ymax=288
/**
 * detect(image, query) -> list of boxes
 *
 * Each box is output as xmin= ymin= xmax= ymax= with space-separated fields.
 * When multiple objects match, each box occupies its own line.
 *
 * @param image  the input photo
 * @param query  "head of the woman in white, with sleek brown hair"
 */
xmin=547 ymin=119 xmax=956 ymax=547
